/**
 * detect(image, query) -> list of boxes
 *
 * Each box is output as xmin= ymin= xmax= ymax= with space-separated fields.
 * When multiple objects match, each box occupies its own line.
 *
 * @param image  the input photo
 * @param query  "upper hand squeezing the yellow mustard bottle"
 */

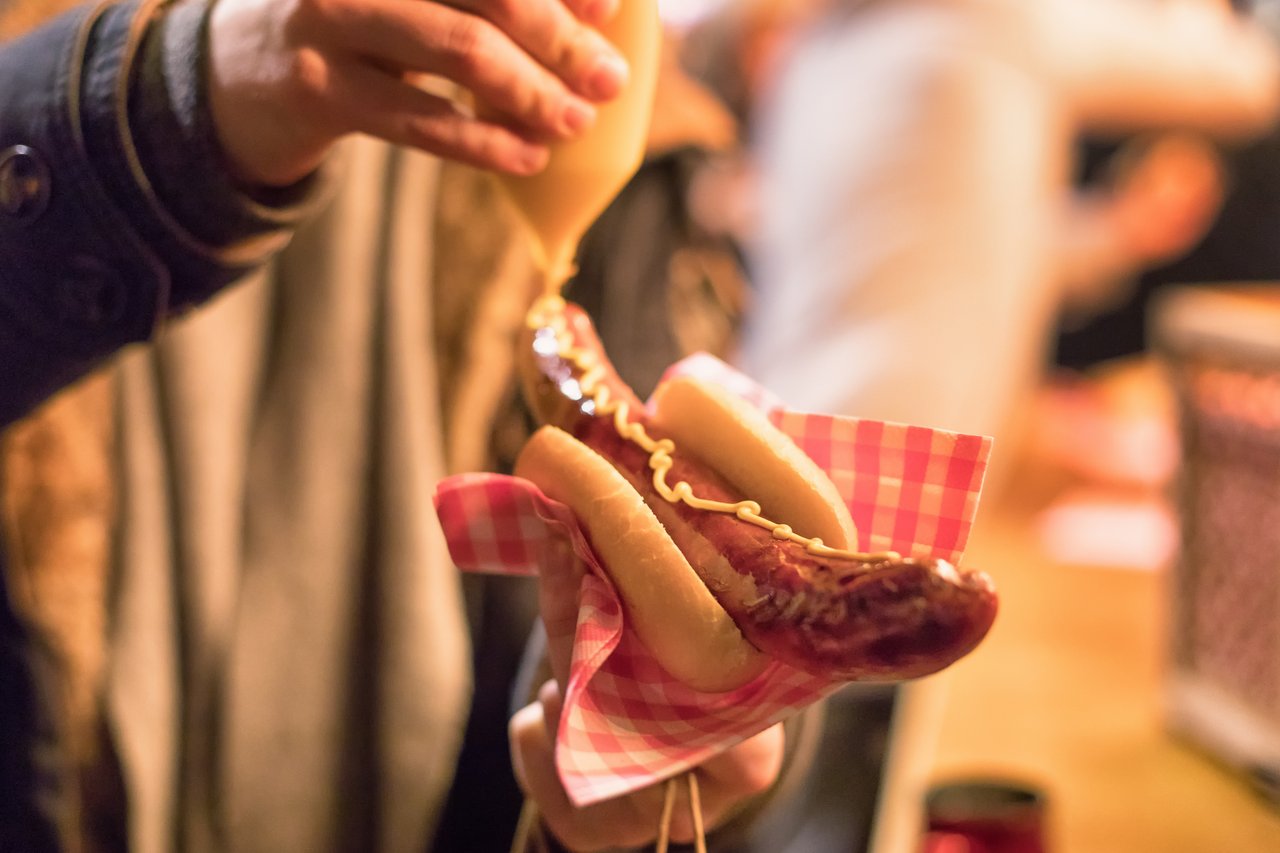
xmin=209 ymin=0 xmax=627 ymax=186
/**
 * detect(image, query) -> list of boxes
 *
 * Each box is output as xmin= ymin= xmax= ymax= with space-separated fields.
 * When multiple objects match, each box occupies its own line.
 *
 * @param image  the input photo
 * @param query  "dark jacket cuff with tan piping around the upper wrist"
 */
xmin=92 ymin=0 xmax=332 ymax=314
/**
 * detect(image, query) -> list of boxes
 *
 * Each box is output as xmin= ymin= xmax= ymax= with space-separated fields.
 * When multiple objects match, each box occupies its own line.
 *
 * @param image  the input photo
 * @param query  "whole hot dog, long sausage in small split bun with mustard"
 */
xmin=516 ymin=297 xmax=996 ymax=690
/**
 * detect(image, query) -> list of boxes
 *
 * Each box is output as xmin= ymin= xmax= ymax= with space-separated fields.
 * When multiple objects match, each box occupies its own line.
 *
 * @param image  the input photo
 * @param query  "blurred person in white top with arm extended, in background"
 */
xmin=742 ymin=0 xmax=1280 ymax=448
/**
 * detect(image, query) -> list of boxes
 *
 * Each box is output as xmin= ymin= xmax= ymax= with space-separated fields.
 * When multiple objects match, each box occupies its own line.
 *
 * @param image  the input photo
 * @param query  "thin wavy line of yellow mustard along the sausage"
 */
xmin=526 ymin=295 xmax=902 ymax=562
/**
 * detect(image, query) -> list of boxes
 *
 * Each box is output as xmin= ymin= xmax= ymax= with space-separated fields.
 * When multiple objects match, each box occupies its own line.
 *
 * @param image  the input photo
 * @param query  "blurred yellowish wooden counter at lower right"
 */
xmin=931 ymin=471 xmax=1280 ymax=853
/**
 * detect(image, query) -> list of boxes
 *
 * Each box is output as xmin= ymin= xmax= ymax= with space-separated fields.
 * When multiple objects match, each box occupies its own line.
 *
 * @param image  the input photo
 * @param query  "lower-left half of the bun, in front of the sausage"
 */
xmin=515 ymin=427 xmax=768 ymax=693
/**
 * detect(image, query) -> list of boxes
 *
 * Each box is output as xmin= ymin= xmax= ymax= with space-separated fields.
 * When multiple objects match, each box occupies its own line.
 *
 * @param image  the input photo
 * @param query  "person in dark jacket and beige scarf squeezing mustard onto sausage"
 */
xmin=0 ymin=0 xmax=781 ymax=853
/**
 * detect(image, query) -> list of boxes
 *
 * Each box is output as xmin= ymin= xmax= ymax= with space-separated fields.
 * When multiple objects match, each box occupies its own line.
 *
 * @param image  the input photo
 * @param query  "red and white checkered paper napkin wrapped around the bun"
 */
xmin=435 ymin=355 xmax=991 ymax=806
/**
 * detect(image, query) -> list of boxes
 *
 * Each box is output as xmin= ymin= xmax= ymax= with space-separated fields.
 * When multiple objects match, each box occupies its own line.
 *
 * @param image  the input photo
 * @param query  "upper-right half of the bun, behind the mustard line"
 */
xmin=653 ymin=377 xmax=858 ymax=548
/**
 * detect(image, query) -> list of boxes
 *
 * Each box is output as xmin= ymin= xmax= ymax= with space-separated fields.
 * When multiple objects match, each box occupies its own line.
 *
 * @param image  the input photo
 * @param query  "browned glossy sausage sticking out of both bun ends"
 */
xmin=521 ymin=298 xmax=997 ymax=681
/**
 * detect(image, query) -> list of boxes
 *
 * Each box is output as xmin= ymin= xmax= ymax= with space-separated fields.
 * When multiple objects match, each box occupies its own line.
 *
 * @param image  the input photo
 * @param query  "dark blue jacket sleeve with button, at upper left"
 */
xmin=0 ymin=0 xmax=325 ymax=427
